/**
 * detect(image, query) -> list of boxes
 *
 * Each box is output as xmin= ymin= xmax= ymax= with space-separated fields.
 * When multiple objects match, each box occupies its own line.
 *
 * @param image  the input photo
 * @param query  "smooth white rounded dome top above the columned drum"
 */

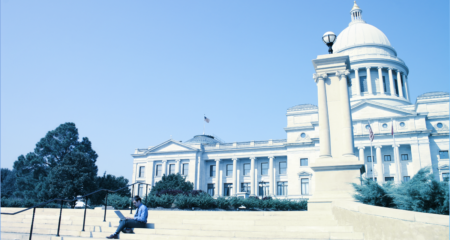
xmin=333 ymin=22 xmax=392 ymax=53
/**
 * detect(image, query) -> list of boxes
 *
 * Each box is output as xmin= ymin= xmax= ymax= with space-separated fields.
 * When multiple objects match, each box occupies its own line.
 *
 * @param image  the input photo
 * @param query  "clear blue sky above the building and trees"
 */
xmin=1 ymin=0 xmax=449 ymax=183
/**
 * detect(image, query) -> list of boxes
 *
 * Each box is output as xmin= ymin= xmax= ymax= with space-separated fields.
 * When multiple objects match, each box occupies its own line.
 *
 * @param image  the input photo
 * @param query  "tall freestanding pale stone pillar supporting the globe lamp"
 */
xmin=308 ymin=54 xmax=363 ymax=211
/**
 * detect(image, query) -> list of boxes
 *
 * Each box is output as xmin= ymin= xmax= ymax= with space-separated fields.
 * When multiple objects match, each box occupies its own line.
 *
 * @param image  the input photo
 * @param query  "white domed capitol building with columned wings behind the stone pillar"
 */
xmin=132 ymin=3 xmax=449 ymax=199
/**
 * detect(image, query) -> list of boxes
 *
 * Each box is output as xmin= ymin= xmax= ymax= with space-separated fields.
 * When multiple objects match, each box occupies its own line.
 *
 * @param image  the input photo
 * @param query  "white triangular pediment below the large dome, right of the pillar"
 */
xmin=352 ymin=101 xmax=417 ymax=120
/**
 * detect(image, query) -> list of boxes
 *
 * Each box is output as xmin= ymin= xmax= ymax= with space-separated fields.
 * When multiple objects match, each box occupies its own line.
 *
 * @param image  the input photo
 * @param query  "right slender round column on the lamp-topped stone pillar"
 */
xmin=336 ymin=70 xmax=355 ymax=156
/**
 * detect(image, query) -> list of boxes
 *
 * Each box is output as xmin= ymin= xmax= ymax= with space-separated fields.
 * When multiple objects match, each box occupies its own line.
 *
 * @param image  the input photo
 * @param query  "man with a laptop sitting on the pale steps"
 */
xmin=106 ymin=196 xmax=148 ymax=239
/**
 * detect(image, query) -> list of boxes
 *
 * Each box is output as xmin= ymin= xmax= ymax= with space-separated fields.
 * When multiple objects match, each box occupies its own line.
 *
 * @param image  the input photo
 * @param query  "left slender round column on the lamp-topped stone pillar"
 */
xmin=313 ymin=74 xmax=331 ymax=157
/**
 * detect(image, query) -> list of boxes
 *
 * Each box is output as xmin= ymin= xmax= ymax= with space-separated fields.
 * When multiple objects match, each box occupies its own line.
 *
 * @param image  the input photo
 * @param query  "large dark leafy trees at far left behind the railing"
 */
xmin=1 ymin=123 xmax=130 ymax=206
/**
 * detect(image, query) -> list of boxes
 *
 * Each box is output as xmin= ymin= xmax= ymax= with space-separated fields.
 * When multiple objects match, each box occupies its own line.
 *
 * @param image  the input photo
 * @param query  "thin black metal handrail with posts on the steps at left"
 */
xmin=1 ymin=183 xmax=149 ymax=240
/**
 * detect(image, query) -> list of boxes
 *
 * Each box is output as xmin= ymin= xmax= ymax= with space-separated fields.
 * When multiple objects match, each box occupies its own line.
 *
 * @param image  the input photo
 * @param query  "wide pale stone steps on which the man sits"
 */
xmin=1 ymin=208 xmax=364 ymax=240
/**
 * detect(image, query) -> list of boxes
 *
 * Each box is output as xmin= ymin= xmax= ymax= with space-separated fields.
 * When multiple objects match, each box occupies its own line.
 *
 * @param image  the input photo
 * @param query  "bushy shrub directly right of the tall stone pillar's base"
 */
xmin=352 ymin=178 xmax=393 ymax=207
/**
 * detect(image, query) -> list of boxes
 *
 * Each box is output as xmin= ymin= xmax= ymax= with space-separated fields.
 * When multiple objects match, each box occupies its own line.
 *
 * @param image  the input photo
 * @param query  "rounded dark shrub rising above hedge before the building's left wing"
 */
xmin=150 ymin=173 xmax=194 ymax=194
